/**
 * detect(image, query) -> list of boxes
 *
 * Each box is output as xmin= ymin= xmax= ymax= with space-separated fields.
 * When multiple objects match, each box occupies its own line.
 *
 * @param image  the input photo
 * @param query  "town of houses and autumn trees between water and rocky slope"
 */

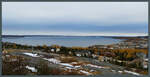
xmin=2 ymin=37 xmax=148 ymax=74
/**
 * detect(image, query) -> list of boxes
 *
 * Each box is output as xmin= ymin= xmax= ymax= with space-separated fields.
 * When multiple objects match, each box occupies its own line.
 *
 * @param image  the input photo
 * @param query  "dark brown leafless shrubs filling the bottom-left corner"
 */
xmin=2 ymin=56 xmax=29 ymax=75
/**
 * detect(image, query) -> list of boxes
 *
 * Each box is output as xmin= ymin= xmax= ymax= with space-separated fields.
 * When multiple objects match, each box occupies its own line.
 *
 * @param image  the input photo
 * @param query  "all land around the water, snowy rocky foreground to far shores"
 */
xmin=2 ymin=36 xmax=148 ymax=76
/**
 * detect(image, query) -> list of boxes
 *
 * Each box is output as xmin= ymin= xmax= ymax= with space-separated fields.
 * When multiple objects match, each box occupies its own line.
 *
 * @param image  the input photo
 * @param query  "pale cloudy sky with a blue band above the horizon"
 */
xmin=2 ymin=2 xmax=148 ymax=36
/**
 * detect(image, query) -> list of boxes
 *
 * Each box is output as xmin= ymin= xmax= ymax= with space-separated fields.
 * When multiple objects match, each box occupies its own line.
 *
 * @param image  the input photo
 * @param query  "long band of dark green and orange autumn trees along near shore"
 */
xmin=2 ymin=42 xmax=148 ymax=61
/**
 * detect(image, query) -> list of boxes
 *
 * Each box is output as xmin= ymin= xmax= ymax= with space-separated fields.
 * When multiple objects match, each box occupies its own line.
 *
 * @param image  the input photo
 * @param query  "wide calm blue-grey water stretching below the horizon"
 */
xmin=2 ymin=36 xmax=121 ymax=47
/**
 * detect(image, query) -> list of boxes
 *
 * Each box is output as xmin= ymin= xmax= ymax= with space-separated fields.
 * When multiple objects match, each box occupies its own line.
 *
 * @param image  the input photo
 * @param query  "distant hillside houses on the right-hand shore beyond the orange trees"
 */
xmin=90 ymin=38 xmax=148 ymax=49
